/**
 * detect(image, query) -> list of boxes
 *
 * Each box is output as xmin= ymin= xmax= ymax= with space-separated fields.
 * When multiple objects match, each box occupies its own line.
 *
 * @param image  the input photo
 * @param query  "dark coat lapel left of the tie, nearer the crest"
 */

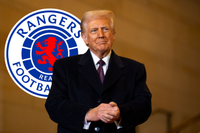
xmin=78 ymin=50 xmax=102 ymax=94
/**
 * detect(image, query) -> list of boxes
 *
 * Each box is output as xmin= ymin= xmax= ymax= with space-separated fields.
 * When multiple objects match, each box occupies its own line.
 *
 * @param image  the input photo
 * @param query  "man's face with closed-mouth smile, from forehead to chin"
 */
xmin=82 ymin=18 xmax=115 ymax=56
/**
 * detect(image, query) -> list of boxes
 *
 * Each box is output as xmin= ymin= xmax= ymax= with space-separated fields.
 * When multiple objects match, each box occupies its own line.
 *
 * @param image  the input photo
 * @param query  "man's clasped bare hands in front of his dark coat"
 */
xmin=86 ymin=102 xmax=120 ymax=123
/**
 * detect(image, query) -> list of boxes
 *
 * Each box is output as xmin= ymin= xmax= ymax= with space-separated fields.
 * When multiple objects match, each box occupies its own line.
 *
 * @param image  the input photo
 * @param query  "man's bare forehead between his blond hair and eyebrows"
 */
xmin=87 ymin=18 xmax=110 ymax=28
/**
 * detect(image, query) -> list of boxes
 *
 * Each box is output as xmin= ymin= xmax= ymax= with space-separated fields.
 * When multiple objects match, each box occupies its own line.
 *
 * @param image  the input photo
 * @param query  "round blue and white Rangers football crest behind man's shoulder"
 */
xmin=5 ymin=9 xmax=88 ymax=99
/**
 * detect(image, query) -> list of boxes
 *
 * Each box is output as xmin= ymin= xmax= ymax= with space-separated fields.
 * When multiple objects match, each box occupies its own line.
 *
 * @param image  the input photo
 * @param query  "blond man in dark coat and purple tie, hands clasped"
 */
xmin=45 ymin=10 xmax=151 ymax=133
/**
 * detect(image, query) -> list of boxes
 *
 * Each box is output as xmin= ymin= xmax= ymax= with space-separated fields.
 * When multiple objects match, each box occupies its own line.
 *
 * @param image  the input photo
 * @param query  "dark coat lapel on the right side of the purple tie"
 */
xmin=102 ymin=51 xmax=124 ymax=93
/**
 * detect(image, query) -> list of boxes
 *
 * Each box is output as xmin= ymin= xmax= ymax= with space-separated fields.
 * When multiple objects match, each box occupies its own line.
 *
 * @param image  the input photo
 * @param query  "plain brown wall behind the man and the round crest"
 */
xmin=0 ymin=0 xmax=200 ymax=133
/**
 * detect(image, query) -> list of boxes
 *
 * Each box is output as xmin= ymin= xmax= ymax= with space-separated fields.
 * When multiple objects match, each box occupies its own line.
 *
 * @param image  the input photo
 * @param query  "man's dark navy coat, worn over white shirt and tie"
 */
xmin=45 ymin=50 xmax=151 ymax=133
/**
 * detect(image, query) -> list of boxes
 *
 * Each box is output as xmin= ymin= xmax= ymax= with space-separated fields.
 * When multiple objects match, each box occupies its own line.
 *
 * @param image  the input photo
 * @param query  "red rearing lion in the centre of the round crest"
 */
xmin=35 ymin=37 xmax=64 ymax=71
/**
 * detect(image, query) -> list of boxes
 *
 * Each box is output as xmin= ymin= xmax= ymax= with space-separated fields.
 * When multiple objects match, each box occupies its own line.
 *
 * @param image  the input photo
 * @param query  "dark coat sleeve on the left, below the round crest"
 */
xmin=45 ymin=61 xmax=89 ymax=132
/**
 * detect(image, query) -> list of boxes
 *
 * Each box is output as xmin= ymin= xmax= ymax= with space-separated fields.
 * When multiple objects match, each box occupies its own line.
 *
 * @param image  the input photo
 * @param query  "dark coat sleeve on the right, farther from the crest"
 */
xmin=119 ymin=64 xmax=152 ymax=128
